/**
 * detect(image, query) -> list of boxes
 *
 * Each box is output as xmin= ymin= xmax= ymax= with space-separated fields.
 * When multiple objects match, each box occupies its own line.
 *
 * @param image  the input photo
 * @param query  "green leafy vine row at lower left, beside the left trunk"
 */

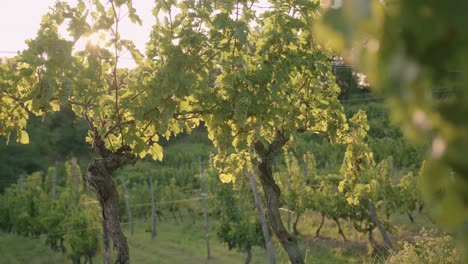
xmin=0 ymin=162 xmax=100 ymax=260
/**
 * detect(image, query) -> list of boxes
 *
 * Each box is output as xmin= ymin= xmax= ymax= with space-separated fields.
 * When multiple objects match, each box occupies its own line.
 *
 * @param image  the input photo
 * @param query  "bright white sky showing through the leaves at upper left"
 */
xmin=0 ymin=0 xmax=154 ymax=57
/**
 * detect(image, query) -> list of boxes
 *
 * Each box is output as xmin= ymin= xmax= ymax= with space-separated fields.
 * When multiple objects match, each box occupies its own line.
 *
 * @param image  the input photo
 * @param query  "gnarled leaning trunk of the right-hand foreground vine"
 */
xmin=254 ymin=132 xmax=304 ymax=264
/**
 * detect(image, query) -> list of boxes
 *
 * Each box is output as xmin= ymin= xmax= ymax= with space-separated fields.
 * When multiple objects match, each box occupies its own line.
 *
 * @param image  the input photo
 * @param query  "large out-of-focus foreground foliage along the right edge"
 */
xmin=322 ymin=0 xmax=468 ymax=262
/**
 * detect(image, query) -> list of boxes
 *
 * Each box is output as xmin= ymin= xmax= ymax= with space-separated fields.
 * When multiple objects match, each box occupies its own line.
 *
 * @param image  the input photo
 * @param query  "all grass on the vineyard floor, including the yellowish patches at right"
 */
xmin=0 ymin=209 xmax=438 ymax=264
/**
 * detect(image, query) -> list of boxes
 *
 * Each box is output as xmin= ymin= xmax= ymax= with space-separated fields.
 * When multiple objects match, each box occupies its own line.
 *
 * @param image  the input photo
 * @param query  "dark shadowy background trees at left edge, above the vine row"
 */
xmin=0 ymin=105 xmax=89 ymax=192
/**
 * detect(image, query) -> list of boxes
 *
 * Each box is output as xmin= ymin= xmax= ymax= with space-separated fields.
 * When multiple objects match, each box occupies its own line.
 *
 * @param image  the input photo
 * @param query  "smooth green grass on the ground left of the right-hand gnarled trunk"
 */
xmin=0 ymin=221 xmax=267 ymax=264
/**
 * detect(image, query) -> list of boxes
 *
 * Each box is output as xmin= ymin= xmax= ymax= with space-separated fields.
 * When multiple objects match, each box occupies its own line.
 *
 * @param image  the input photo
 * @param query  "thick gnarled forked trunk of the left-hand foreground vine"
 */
xmin=86 ymin=133 xmax=136 ymax=264
